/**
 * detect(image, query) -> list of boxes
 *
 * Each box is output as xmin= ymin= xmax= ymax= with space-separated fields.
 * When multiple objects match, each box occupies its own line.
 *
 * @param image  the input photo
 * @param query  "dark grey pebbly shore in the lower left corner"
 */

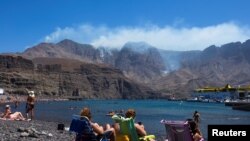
xmin=0 ymin=120 xmax=75 ymax=141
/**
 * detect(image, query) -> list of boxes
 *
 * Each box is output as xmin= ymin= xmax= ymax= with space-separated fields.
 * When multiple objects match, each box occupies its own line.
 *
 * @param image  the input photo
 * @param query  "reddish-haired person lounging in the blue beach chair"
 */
xmin=80 ymin=107 xmax=115 ymax=141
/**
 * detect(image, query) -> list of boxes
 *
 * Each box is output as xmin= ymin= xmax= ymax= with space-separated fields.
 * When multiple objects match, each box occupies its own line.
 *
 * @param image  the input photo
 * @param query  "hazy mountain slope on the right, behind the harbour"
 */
xmin=151 ymin=40 xmax=250 ymax=96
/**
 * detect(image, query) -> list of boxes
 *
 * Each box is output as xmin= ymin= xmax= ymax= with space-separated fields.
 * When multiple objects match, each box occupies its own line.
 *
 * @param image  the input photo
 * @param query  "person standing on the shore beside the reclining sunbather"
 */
xmin=26 ymin=91 xmax=35 ymax=119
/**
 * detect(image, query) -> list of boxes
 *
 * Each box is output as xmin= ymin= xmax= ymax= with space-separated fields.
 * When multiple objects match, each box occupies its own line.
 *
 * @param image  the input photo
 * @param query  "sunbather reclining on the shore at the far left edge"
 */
xmin=1 ymin=105 xmax=25 ymax=120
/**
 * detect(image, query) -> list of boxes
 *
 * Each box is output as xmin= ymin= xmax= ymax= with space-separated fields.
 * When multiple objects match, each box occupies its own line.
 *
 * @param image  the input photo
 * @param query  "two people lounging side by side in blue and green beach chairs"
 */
xmin=76 ymin=107 xmax=153 ymax=141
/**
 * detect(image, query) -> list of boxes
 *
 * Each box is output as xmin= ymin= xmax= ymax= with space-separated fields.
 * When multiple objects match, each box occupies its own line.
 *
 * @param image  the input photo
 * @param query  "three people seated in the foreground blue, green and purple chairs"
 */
xmin=73 ymin=107 xmax=203 ymax=141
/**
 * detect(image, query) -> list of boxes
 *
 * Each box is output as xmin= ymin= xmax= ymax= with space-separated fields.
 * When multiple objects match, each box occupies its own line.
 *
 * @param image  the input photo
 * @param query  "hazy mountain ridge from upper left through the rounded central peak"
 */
xmin=20 ymin=39 xmax=165 ymax=82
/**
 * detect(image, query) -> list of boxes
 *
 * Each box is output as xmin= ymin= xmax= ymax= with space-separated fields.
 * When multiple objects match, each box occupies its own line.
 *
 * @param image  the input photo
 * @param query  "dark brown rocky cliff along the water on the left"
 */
xmin=0 ymin=55 xmax=160 ymax=99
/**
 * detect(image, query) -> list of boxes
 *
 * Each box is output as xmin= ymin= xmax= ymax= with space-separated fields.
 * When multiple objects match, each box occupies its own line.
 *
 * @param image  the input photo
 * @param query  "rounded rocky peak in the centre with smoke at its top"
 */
xmin=115 ymin=43 xmax=165 ymax=83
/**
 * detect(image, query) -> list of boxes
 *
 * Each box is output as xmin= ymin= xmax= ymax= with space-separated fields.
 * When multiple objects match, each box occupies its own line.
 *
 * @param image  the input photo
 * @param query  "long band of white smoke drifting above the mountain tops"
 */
xmin=44 ymin=22 xmax=250 ymax=51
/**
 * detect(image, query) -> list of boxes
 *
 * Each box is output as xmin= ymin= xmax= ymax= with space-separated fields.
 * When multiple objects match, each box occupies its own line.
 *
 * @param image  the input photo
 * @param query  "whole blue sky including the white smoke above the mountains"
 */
xmin=0 ymin=0 xmax=250 ymax=53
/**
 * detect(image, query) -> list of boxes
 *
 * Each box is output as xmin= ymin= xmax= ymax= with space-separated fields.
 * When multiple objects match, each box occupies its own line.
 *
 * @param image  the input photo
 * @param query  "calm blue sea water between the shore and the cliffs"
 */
xmin=11 ymin=100 xmax=250 ymax=138
